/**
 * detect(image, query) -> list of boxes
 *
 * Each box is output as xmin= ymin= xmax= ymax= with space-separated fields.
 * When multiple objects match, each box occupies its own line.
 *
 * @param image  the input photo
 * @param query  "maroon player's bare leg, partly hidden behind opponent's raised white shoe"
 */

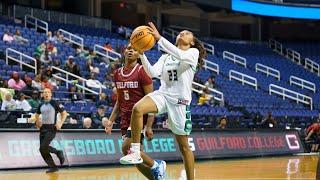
xmin=122 ymin=138 xmax=154 ymax=180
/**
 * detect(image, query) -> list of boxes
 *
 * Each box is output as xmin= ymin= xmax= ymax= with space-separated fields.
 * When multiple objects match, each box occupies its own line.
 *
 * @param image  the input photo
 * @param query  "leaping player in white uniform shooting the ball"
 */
xmin=120 ymin=23 xmax=206 ymax=180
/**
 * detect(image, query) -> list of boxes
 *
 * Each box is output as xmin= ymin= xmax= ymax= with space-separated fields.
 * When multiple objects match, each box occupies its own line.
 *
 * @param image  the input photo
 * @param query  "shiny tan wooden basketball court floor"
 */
xmin=0 ymin=155 xmax=318 ymax=180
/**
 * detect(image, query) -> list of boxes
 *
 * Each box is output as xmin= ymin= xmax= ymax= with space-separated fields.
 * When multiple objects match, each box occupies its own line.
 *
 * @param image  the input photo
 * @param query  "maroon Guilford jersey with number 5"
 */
xmin=114 ymin=64 xmax=152 ymax=130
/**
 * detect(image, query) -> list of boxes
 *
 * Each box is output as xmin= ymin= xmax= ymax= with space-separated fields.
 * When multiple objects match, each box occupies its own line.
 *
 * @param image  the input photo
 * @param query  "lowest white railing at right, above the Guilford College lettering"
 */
xmin=269 ymin=84 xmax=313 ymax=110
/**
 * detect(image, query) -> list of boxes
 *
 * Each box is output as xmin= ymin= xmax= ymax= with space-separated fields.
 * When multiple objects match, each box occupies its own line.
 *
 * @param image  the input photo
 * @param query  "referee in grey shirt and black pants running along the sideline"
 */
xmin=28 ymin=88 xmax=68 ymax=173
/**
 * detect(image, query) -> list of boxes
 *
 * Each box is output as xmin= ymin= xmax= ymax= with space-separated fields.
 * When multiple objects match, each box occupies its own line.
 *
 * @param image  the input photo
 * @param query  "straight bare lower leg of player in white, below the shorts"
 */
xmin=175 ymin=135 xmax=194 ymax=180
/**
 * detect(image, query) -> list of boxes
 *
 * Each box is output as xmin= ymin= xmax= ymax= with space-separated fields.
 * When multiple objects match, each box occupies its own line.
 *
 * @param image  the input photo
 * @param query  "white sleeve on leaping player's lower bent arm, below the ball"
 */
xmin=140 ymin=54 xmax=168 ymax=77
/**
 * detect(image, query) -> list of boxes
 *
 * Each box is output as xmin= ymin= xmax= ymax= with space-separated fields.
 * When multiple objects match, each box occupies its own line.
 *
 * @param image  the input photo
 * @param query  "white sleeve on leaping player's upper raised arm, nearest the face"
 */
xmin=158 ymin=37 xmax=199 ymax=67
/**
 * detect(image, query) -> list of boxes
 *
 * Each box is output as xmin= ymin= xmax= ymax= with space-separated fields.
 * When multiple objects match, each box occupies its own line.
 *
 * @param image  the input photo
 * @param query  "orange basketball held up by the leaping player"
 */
xmin=130 ymin=26 xmax=156 ymax=51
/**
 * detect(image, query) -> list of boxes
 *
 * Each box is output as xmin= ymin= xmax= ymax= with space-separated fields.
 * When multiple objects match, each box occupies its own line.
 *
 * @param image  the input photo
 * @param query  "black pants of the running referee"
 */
xmin=39 ymin=124 xmax=59 ymax=168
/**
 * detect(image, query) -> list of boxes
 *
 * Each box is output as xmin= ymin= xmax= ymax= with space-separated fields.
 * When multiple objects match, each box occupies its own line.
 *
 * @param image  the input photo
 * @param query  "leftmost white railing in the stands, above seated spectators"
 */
xmin=6 ymin=48 xmax=37 ymax=75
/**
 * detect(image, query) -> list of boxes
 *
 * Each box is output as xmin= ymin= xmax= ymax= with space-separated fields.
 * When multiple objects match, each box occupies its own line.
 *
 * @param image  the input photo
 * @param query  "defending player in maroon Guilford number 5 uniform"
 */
xmin=105 ymin=44 xmax=159 ymax=179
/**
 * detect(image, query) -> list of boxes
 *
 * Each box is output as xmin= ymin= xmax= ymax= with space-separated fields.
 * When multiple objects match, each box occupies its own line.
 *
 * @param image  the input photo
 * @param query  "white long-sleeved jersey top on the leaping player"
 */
xmin=140 ymin=37 xmax=199 ymax=104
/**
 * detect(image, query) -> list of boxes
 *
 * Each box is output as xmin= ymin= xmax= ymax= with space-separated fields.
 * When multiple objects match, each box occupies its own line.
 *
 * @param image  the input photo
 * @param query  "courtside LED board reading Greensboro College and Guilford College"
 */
xmin=0 ymin=129 xmax=304 ymax=169
